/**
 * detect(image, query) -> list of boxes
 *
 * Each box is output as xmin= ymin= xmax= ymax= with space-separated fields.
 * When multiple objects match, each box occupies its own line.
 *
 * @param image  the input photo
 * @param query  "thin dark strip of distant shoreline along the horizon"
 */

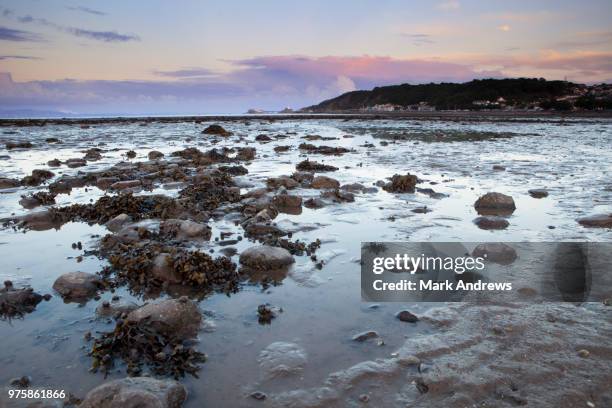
xmin=0 ymin=111 xmax=612 ymax=127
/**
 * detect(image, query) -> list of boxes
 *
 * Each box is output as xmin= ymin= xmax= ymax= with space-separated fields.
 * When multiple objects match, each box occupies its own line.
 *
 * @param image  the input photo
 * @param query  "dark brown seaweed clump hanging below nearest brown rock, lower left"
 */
xmin=89 ymin=315 xmax=206 ymax=380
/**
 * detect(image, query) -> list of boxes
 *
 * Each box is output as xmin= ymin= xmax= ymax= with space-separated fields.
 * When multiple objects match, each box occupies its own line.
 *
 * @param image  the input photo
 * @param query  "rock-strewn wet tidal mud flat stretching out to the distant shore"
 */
xmin=0 ymin=113 xmax=612 ymax=407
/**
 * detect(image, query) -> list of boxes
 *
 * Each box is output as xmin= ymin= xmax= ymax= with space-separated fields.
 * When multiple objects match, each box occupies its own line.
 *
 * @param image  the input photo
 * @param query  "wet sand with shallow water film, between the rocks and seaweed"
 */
xmin=0 ymin=115 xmax=612 ymax=407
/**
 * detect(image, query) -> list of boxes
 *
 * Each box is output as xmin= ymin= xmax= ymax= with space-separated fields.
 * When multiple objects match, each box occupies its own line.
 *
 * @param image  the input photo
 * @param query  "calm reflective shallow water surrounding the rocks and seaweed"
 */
xmin=0 ymin=116 xmax=612 ymax=407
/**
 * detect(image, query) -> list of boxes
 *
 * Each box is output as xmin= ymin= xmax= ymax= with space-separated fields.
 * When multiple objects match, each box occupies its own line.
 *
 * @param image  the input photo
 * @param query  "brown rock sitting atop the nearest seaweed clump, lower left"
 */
xmin=127 ymin=296 xmax=202 ymax=339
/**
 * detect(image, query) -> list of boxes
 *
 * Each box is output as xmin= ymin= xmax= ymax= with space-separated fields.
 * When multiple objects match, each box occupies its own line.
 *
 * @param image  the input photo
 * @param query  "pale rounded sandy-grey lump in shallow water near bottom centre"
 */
xmin=257 ymin=341 xmax=307 ymax=378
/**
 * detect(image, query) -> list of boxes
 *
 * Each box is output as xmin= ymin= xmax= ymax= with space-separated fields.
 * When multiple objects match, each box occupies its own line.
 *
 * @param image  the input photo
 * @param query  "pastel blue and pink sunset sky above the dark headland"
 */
xmin=0 ymin=0 xmax=612 ymax=115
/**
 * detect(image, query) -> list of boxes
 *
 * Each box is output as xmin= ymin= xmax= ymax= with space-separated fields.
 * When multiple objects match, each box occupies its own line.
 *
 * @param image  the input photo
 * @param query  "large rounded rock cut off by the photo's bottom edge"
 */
xmin=79 ymin=377 xmax=187 ymax=408
